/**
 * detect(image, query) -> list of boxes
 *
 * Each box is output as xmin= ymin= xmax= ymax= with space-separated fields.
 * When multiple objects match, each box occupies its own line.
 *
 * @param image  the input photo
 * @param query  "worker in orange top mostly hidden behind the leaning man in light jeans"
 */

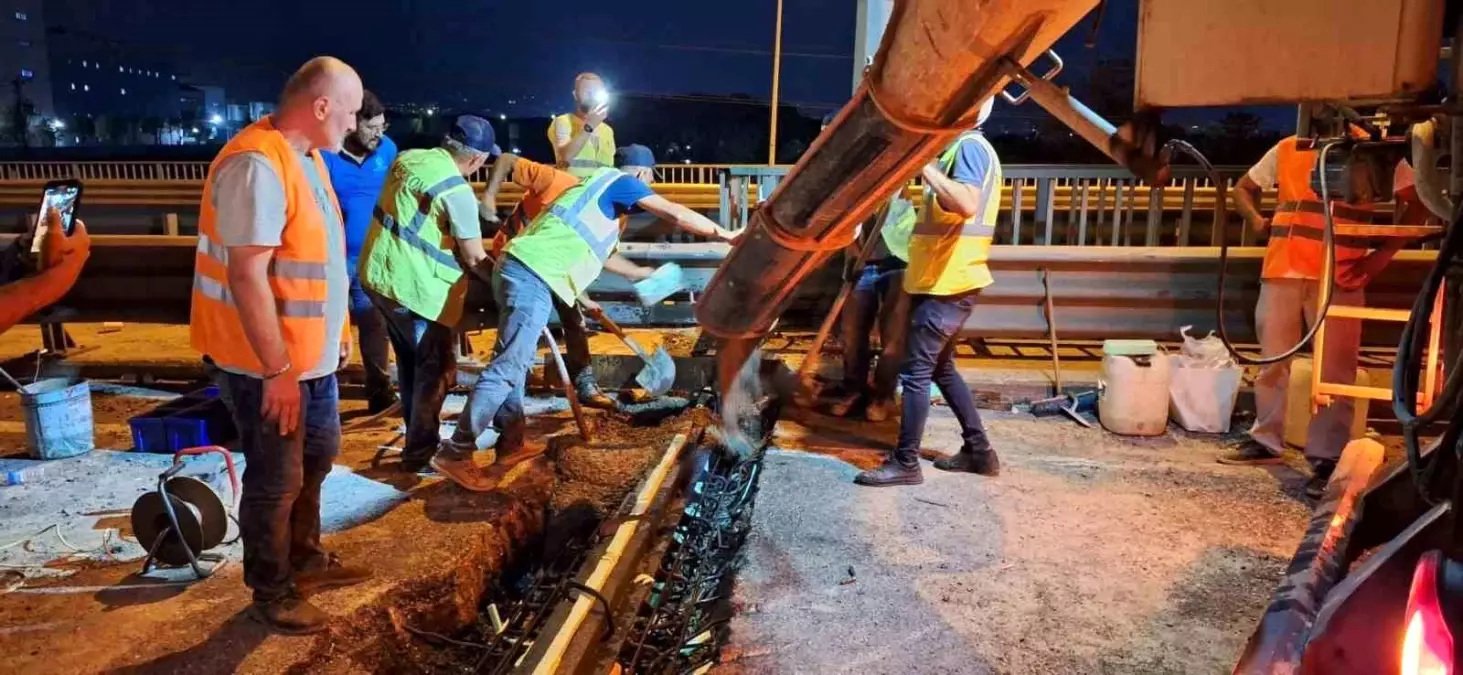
xmin=480 ymin=145 xmax=654 ymax=409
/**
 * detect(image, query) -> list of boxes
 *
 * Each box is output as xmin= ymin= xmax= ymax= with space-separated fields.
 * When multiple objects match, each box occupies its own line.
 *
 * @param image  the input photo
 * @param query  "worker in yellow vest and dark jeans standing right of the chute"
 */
xmin=854 ymin=100 xmax=1002 ymax=488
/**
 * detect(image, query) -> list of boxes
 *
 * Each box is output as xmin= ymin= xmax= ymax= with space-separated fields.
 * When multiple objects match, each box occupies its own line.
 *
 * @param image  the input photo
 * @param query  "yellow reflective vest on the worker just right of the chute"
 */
xmin=904 ymin=132 xmax=1002 ymax=296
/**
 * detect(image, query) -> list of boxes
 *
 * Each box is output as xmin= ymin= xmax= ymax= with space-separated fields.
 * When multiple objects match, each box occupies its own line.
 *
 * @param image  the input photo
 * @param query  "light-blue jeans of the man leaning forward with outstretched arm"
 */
xmin=442 ymin=255 xmax=553 ymax=458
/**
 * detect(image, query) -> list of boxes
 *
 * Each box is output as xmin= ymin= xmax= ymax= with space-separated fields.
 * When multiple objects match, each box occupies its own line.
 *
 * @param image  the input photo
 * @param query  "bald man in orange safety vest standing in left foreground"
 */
xmin=190 ymin=57 xmax=370 ymax=634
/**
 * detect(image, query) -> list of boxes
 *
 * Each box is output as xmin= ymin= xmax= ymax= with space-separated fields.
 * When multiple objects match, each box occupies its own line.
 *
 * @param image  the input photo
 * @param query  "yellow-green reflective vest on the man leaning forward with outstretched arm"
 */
xmin=505 ymin=168 xmax=625 ymax=305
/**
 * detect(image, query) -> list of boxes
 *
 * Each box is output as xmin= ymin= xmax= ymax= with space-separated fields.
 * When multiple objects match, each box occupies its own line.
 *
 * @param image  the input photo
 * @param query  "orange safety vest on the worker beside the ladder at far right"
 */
xmin=1260 ymin=136 xmax=1385 ymax=280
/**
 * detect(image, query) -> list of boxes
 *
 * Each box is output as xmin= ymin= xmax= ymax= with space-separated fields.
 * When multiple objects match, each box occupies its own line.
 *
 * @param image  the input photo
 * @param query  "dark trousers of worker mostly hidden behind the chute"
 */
xmin=843 ymin=258 xmax=910 ymax=401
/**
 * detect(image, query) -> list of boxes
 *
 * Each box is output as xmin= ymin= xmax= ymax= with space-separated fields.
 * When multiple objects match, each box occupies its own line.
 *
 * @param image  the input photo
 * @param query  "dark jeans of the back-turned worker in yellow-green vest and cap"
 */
xmin=367 ymin=286 xmax=456 ymax=469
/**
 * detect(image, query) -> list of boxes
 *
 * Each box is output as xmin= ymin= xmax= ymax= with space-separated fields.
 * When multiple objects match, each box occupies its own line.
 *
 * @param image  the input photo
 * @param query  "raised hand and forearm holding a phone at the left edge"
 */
xmin=0 ymin=209 xmax=91 ymax=332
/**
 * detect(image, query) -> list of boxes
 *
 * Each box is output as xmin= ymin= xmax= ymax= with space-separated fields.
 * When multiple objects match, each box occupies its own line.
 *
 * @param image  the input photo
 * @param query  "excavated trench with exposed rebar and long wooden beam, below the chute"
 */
xmin=351 ymin=352 xmax=790 ymax=674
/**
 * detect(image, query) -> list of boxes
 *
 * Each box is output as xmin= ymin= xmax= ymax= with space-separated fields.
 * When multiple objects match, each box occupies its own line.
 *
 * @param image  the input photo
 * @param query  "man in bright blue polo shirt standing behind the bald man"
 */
xmin=322 ymin=91 xmax=396 ymax=414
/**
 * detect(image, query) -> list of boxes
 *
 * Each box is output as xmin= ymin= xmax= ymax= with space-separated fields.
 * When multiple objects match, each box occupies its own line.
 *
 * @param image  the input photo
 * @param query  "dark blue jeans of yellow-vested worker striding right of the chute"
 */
xmin=894 ymin=291 xmax=990 ymax=467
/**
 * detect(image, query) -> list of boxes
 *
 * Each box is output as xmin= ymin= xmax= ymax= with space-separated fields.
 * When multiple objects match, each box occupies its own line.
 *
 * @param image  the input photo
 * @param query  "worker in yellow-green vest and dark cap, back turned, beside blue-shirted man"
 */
xmin=360 ymin=116 xmax=497 ymax=473
